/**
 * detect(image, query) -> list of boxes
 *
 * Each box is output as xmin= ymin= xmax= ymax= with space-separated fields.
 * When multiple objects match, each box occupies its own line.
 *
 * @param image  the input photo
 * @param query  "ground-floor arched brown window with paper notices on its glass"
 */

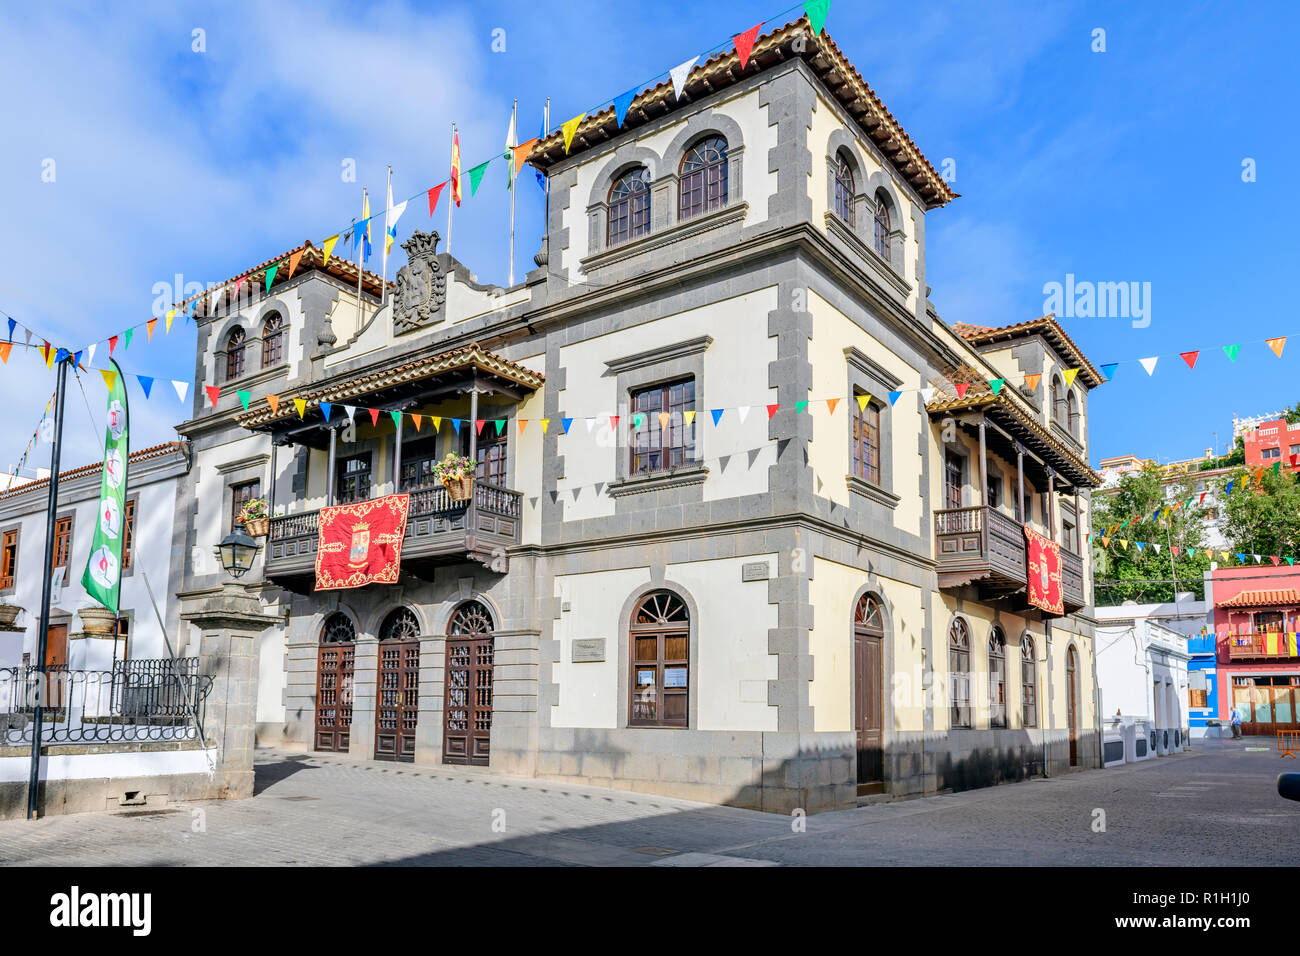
xmin=628 ymin=591 xmax=690 ymax=727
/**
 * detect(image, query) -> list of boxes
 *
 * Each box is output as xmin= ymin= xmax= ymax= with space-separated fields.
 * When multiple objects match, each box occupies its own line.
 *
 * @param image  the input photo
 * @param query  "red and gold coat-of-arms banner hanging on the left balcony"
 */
xmin=316 ymin=494 xmax=411 ymax=591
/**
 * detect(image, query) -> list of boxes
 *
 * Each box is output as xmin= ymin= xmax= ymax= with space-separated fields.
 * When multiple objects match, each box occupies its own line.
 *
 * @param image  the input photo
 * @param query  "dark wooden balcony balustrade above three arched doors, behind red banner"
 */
xmin=264 ymin=481 xmax=524 ymax=593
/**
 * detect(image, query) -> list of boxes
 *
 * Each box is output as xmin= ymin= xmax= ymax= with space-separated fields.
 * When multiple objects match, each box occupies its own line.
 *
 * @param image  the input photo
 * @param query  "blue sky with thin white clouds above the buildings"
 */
xmin=0 ymin=0 xmax=1300 ymax=476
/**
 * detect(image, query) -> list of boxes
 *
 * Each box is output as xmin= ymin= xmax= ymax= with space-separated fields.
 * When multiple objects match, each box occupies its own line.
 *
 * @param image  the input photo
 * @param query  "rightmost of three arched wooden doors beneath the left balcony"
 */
xmin=442 ymin=601 xmax=493 ymax=766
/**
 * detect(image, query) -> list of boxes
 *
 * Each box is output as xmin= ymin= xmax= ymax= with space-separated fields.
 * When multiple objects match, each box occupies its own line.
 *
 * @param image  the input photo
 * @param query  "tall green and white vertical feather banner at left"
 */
xmin=82 ymin=359 xmax=130 ymax=614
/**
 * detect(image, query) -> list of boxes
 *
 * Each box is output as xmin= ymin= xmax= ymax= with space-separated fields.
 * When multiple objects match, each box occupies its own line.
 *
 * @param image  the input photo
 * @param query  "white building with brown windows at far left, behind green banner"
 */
xmin=0 ymin=442 xmax=190 ymax=670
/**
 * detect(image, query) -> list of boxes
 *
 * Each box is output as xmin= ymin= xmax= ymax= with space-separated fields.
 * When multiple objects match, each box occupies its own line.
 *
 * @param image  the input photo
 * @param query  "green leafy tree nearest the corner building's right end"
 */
xmin=1092 ymin=463 xmax=1210 ymax=605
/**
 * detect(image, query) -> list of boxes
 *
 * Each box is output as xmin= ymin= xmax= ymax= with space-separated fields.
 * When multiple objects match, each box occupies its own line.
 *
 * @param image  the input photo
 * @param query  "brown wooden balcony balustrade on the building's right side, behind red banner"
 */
xmin=935 ymin=506 xmax=1087 ymax=614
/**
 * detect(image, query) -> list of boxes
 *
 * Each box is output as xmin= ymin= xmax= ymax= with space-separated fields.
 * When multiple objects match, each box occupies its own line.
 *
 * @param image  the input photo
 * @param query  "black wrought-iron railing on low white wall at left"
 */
xmin=0 ymin=657 xmax=212 ymax=747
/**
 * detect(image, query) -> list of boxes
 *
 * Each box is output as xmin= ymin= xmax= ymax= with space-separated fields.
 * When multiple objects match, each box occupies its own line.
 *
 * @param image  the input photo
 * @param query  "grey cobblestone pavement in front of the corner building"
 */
xmin=0 ymin=739 xmax=1300 ymax=866
